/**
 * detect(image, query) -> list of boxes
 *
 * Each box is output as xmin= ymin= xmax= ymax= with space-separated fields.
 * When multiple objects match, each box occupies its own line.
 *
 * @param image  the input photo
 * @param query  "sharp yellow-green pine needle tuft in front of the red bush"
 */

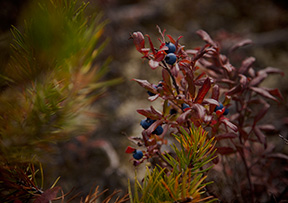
xmin=129 ymin=127 xmax=215 ymax=203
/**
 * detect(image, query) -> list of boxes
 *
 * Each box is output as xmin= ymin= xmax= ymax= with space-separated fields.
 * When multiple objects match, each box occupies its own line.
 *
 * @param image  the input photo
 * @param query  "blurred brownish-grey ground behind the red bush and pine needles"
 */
xmin=0 ymin=0 xmax=288 ymax=201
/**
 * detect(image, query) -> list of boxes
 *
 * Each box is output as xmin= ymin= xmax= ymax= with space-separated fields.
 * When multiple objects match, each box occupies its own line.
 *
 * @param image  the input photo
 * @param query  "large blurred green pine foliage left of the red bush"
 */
xmin=0 ymin=0 xmax=119 ymax=163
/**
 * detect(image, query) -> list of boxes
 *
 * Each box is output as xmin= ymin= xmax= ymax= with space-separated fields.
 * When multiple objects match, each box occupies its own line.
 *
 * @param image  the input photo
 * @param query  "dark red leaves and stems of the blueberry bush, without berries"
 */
xmin=132 ymin=29 xmax=283 ymax=203
